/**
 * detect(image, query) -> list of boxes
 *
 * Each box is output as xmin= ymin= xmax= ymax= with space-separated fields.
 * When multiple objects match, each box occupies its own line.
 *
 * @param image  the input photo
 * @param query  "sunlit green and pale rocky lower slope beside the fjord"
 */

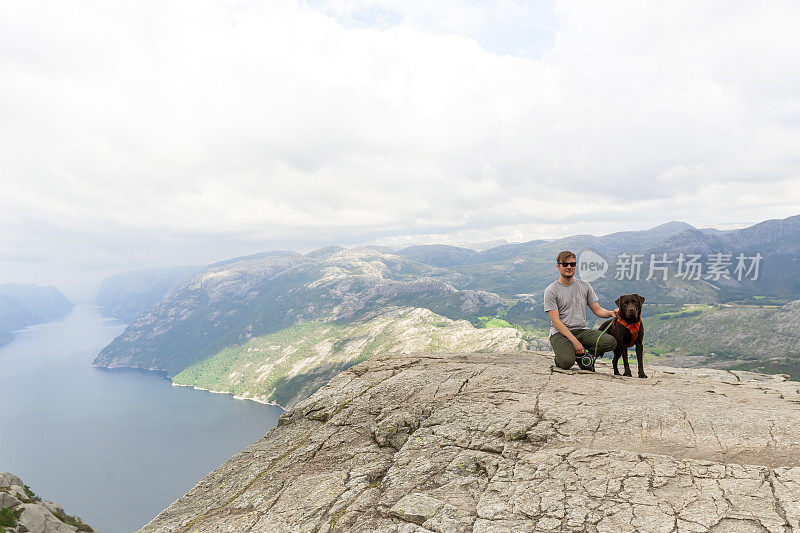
xmin=173 ymin=308 xmax=525 ymax=406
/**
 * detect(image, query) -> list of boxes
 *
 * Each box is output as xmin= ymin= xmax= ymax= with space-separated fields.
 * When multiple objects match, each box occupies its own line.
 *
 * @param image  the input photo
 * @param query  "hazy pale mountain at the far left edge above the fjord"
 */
xmin=0 ymin=283 xmax=75 ymax=345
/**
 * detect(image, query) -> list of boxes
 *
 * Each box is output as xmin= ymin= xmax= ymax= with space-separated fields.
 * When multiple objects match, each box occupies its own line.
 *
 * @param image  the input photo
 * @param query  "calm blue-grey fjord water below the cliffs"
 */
xmin=0 ymin=306 xmax=282 ymax=533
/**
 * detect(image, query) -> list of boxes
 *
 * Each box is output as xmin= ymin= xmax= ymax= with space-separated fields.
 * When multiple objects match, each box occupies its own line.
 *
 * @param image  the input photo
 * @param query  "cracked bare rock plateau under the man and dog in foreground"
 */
xmin=143 ymin=352 xmax=800 ymax=533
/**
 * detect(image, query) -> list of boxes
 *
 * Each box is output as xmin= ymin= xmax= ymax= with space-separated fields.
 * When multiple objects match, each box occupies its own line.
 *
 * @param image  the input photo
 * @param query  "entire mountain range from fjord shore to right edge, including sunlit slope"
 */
xmin=94 ymin=212 xmax=800 ymax=405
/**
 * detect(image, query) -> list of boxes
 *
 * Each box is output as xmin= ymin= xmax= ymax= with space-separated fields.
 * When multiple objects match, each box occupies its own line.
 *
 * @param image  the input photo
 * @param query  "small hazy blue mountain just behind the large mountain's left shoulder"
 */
xmin=95 ymin=266 xmax=200 ymax=323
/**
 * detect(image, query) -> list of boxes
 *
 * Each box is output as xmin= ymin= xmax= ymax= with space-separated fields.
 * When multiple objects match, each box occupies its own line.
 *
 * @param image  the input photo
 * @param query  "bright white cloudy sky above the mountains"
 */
xmin=0 ymin=0 xmax=800 ymax=298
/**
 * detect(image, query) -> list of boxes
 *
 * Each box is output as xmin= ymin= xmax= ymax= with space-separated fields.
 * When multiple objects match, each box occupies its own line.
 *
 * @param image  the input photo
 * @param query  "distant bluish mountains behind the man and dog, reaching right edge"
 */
xmin=444 ymin=215 xmax=800 ymax=310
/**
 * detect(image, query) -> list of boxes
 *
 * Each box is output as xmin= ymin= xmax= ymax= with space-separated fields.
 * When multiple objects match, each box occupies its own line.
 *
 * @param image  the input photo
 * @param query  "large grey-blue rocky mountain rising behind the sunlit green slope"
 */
xmin=94 ymin=248 xmax=503 ymax=376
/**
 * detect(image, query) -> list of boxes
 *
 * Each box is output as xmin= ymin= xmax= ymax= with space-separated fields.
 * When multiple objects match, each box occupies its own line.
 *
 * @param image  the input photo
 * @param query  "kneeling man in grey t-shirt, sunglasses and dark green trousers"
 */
xmin=544 ymin=250 xmax=619 ymax=370
